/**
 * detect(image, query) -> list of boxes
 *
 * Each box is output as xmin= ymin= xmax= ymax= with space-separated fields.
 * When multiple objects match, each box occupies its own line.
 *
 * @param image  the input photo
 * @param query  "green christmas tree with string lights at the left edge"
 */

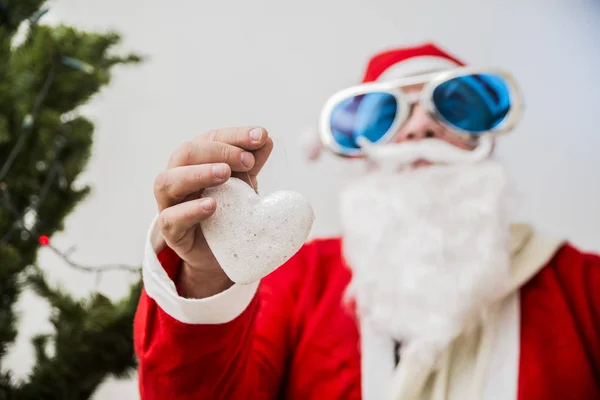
xmin=0 ymin=0 xmax=141 ymax=400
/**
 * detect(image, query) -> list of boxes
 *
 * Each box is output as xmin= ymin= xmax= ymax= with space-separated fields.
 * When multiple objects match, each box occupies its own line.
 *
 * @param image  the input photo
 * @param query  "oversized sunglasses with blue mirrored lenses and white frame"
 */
xmin=319 ymin=68 xmax=521 ymax=156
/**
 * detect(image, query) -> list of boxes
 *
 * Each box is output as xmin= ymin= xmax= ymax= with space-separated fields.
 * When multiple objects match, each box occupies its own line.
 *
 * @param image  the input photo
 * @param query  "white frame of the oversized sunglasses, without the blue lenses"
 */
xmin=318 ymin=67 xmax=523 ymax=157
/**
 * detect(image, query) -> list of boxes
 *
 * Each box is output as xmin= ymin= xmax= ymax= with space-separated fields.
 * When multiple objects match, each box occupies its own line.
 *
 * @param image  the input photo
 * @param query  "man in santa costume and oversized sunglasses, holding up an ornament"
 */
xmin=135 ymin=44 xmax=600 ymax=400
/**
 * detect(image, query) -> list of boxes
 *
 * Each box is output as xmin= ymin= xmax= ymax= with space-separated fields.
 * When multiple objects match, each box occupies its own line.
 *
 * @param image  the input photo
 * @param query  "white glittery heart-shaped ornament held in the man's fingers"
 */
xmin=201 ymin=178 xmax=314 ymax=284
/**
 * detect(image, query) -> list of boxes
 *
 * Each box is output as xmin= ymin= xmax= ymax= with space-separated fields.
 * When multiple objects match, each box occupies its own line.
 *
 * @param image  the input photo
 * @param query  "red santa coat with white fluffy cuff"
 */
xmin=135 ymin=239 xmax=600 ymax=400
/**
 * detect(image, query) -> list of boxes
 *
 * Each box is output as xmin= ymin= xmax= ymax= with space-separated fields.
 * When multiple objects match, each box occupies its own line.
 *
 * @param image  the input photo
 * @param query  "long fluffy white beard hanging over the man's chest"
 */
xmin=341 ymin=155 xmax=510 ymax=363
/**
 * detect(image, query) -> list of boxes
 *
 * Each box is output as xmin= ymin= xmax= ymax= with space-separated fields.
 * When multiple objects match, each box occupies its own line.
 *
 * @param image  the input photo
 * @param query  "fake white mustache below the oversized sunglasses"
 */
xmin=356 ymin=136 xmax=493 ymax=170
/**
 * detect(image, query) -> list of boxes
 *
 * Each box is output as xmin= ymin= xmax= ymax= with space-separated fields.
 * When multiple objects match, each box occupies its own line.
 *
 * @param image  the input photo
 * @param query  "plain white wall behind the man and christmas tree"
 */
xmin=2 ymin=0 xmax=600 ymax=400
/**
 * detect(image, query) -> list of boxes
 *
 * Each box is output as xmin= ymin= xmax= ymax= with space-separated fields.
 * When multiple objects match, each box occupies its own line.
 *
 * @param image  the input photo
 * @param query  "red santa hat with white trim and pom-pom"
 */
xmin=303 ymin=43 xmax=465 ymax=160
